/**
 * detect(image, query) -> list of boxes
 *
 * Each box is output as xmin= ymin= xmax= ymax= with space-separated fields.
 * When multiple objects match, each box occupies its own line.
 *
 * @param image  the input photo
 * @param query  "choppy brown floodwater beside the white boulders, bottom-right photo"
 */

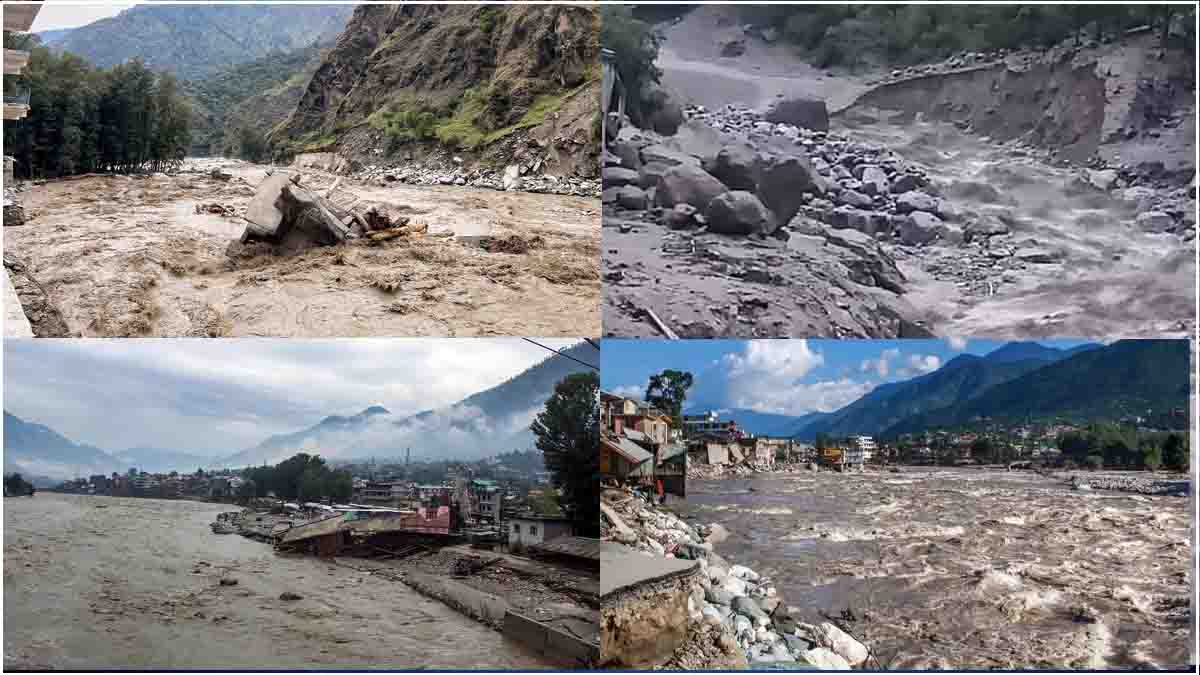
xmin=677 ymin=468 xmax=1193 ymax=669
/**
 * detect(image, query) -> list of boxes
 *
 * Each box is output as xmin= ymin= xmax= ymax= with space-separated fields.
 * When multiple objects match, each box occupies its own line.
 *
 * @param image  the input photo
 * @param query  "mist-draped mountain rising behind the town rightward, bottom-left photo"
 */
xmin=216 ymin=344 xmax=598 ymax=467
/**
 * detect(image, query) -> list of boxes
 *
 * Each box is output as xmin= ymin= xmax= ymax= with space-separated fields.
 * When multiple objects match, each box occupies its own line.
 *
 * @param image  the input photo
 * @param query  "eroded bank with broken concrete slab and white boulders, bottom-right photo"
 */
xmin=601 ymin=491 xmax=871 ymax=670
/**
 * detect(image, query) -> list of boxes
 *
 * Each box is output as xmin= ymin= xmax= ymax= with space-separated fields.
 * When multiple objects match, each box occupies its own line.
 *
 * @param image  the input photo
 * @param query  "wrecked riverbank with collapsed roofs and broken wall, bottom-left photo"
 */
xmin=212 ymin=491 xmax=600 ymax=668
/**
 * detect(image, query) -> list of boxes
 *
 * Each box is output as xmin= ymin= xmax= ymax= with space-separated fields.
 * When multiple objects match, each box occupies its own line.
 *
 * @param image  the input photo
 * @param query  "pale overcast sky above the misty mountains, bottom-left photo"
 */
xmin=4 ymin=339 xmax=576 ymax=456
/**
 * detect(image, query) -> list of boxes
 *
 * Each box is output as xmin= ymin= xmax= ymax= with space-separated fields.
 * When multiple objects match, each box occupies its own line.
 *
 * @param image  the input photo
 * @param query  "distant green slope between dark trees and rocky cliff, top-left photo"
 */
xmin=182 ymin=44 xmax=324 ymax=156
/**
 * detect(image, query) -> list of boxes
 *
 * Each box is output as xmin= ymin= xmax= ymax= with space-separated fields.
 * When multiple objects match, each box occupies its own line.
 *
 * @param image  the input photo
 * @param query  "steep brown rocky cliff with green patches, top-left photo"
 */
xmin=271 ymin=5 xmax=599 ymax=168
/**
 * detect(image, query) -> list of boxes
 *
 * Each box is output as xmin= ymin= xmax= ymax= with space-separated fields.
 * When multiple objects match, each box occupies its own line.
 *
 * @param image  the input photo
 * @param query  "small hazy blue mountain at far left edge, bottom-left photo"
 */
xmin=4 ymin=411 xmax=128 ymax=479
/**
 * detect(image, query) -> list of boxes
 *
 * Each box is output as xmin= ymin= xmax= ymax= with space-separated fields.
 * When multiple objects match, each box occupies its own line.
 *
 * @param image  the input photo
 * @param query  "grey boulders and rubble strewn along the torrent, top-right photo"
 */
xmin=601 ymin=97 xmax=1196 ymax=307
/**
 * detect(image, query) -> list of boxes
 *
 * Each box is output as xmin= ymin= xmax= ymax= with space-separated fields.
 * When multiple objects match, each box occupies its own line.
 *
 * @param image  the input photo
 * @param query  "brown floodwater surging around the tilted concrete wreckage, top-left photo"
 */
xmin=5 ymin=160 xmax=600 ymax=338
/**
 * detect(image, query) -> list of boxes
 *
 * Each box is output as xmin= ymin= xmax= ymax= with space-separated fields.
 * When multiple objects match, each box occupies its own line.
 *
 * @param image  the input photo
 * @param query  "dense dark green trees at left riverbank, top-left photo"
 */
xmin=4 ymin=32 xmax=192 ymax=178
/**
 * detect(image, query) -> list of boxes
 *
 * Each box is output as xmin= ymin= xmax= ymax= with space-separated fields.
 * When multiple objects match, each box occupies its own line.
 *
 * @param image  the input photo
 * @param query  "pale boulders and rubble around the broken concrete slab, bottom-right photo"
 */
xmin=601 ymin=485 xmax=878 ymax=670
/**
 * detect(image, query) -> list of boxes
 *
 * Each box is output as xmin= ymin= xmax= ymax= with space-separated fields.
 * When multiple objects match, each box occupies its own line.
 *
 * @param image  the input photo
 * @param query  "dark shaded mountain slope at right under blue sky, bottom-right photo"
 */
xmin=884 ymin=340 xmax=1190 ymax=436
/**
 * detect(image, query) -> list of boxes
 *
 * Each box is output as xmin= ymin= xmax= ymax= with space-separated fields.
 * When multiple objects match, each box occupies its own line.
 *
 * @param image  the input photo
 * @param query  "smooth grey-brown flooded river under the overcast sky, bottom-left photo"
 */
xmin=4 ymin=492 xmax=546 ymax=670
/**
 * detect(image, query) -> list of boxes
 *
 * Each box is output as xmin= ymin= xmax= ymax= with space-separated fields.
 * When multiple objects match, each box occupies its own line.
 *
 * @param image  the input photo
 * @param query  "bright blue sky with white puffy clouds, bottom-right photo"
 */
xmin=600 ymin=339 xmax=1099 ymax=416
